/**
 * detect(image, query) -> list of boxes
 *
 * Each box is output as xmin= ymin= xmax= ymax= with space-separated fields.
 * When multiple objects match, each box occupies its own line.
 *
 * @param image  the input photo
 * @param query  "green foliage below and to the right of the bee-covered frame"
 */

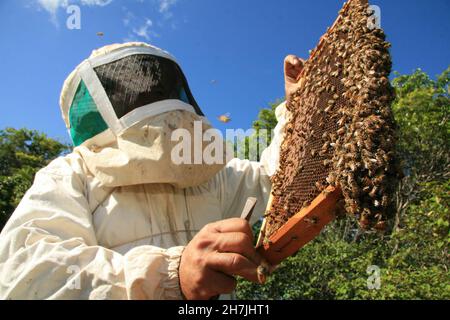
xmin=237 ymin=68 xmax=450 ymax=299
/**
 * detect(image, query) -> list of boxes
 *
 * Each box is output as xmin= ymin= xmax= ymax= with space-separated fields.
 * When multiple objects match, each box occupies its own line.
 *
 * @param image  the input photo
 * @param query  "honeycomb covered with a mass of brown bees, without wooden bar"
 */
xmin=265 ymin=0 xmax=398 ymax=241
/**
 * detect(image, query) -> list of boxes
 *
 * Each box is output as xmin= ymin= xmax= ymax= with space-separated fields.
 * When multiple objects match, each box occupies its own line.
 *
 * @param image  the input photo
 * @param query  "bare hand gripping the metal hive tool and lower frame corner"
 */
xmin=179 ymin=218 xmax=261 ymax=300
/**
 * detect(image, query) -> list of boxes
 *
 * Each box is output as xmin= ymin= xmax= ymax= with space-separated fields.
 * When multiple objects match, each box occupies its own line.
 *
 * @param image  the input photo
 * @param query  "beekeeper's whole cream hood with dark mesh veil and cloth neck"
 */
xmin=60 ymin=43 xmax=226 ymax=188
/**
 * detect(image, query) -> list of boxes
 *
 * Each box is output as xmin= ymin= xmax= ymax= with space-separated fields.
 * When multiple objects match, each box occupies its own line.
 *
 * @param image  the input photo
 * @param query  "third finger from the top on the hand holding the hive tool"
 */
xmin=206 ymin=252 xmax=259 ymax=283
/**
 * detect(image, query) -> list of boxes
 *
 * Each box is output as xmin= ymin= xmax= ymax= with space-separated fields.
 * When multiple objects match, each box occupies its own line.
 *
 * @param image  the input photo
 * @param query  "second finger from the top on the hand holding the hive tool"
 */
xmin=215 ymin=232 xmax=262 ymax=265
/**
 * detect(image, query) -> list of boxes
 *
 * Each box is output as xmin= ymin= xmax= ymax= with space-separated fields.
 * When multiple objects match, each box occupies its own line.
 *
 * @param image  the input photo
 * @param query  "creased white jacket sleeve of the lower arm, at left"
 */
xmin=0 ymin=155 xmax=183 ymax=299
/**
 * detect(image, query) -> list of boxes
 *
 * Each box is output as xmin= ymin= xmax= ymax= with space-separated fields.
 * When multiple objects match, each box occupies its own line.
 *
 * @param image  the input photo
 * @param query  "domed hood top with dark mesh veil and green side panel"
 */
xmin=61 ymin=43 xmax=203 ymax=146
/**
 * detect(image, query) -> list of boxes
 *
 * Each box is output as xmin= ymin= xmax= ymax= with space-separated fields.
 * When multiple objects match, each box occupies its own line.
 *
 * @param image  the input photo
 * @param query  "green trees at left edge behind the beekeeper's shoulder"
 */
xmin=0 ymin=128 xmax=68 ymax=229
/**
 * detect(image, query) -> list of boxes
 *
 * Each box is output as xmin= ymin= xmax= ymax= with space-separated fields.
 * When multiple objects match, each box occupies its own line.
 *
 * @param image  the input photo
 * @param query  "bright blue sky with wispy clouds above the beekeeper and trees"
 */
xmin=0 ymin=0 xmax=450 ymax=142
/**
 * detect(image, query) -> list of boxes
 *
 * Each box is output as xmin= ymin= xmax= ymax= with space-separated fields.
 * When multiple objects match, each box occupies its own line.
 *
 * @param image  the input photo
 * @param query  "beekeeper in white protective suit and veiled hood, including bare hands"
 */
xmin=0 ymin=43 xmax=302 ymax=299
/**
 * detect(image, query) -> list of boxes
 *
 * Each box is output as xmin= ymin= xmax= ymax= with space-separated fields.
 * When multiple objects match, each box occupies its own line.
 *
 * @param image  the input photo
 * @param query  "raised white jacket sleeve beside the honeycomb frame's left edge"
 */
xmin=219 ymin=102 xmax=289 ymax=224
